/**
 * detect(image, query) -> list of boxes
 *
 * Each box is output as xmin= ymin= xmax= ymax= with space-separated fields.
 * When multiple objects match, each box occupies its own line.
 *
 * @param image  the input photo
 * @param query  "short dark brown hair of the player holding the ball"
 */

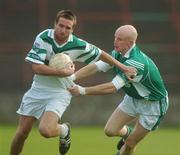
xmin=55 ymin=10 xmax=76 ymax=27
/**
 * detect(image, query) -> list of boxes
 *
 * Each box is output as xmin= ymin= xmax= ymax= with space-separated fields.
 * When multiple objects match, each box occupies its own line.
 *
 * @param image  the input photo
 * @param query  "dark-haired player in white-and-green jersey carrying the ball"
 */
xmin=10 ymin=10 xmax=136 ymax=155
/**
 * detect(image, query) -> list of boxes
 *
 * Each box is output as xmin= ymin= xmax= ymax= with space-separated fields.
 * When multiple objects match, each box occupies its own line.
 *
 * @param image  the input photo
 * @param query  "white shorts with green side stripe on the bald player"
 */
xmin=118 ymin=95 xmax=169 ymax=130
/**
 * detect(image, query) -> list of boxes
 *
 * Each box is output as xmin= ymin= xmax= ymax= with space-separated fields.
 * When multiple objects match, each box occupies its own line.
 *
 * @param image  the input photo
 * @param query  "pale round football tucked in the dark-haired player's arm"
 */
xmin=49 ymin=53 xmax=73 ymax=69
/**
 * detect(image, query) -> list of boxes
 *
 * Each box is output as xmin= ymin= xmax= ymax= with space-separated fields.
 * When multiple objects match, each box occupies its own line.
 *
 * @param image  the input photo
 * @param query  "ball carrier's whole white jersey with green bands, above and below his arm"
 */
xmin=25 ymin=29 xmax=102 ymax=92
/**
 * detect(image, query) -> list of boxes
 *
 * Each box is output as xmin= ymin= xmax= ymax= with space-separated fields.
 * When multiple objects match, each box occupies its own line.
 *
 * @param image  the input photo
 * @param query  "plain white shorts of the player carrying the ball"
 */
xmin=17 ymin=88 xmax=72 ymax=119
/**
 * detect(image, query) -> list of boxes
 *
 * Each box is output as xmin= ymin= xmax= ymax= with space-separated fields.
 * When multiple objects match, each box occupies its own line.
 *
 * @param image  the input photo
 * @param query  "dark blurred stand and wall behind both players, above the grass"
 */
xmin=0 ymin=0 xmax=180 ymax=127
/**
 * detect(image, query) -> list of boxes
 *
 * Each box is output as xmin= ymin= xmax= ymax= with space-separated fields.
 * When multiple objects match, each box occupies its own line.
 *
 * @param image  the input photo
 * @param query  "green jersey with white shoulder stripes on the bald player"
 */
xmin=112 ymin=46 xmax=167 ymax=101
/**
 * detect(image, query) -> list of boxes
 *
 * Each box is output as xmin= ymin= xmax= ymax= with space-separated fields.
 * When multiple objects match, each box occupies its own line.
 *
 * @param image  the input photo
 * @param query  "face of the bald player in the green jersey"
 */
xmin=114 ymin=31 xmax=129 ymax=53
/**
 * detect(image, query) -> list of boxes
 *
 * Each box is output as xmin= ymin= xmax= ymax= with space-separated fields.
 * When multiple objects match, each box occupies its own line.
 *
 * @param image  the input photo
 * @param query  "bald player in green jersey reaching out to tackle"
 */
xmin=69 ymin=25 xmax=168 ymax=155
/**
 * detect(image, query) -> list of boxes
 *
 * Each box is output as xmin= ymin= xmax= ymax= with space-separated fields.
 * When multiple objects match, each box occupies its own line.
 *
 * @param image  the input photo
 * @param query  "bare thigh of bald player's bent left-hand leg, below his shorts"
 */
xmin=105 ymin=107 xmax=134 ymax=133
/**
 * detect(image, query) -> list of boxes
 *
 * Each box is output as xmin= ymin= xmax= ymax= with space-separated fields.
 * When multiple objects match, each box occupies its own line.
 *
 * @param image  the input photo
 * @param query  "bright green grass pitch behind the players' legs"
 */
xmin=0 ymin=126 xmax=180 ymax=155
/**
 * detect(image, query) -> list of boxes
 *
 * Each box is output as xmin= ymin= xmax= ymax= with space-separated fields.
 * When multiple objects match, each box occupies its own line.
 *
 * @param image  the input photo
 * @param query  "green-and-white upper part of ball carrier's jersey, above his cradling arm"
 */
xmin=25 ymin=29 xmax=101 ymax=64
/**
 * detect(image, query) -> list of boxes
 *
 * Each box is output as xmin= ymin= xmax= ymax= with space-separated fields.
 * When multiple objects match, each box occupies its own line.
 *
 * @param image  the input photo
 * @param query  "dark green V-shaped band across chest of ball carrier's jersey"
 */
xmin=40 ymin=30 xmax=86 ymax=54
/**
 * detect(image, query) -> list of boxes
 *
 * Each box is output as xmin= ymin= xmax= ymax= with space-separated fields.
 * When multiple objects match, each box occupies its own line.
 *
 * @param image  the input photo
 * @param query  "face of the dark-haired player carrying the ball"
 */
xmin=54 ymin=17 xmax=74 ymax=43
